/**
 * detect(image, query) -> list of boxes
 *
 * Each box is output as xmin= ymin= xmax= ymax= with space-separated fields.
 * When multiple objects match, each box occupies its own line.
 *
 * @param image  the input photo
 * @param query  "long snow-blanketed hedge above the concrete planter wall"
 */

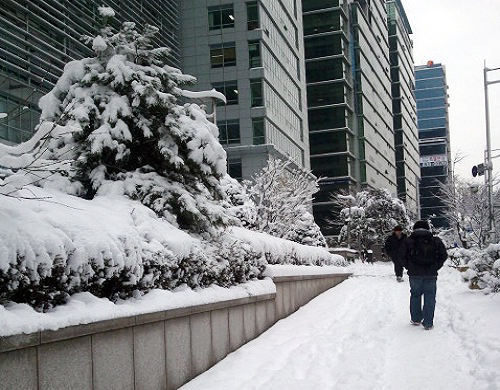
xmin=0 ymin=186 xmax=343 ymax=311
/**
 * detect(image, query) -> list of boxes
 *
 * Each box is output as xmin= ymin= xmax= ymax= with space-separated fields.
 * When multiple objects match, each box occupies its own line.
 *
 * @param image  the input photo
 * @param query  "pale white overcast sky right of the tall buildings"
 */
xmin=402 ymin=0 xmax=500 ymax=181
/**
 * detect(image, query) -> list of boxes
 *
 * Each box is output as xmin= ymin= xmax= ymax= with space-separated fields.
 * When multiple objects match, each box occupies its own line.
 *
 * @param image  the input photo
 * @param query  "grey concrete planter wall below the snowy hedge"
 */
xmin=0 ymin=274 xmax=349 ymax=390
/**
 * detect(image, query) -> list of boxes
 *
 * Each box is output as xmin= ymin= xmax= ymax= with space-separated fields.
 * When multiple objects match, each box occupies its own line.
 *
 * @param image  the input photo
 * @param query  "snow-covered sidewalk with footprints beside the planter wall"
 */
xmin=182 ymin=264 xmax=500 ymax=390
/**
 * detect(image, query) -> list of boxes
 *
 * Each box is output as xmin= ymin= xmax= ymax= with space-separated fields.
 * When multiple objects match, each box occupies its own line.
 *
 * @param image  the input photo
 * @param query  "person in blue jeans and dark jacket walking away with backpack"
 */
xmin=401 ymin=221 xmax=448 ymax=330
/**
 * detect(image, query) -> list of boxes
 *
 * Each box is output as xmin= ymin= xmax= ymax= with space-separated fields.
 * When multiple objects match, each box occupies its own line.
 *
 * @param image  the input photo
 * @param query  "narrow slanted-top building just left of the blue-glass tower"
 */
xmin=387 ymin=0 xmax=420 ymax=213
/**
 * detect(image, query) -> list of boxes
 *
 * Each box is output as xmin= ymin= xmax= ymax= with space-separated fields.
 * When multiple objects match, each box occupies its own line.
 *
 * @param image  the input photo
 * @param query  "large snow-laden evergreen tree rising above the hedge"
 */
xmin=40 ymin=7 xmax=231 ymax=234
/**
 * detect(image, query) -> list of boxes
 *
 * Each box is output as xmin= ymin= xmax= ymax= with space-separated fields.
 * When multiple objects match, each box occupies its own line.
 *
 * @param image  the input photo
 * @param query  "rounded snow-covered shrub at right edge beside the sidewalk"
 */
xmin=463 ymin=244 xmax=500 ymax=293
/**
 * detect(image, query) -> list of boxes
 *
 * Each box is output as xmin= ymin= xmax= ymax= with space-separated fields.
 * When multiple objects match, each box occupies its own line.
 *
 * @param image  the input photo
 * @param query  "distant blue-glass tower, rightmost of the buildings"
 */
xmin=415 ymin=61 xmax=451 ymax=227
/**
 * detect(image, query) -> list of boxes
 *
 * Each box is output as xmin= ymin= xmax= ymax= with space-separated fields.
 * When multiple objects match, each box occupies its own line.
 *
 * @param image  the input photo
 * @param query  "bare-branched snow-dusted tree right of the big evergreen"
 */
xmin=244 ymin=157 xmax=326 ymax=247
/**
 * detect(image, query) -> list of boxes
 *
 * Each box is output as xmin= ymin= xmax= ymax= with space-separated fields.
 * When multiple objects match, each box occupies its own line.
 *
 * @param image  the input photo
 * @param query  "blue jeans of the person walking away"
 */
xmin=409 ymin=276 xmax=437 ymax=326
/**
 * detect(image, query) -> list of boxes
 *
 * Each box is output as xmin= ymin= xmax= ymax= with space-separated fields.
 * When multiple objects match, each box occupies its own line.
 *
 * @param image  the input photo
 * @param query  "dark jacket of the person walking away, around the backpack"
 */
xmin=401 ymin=229 xmax=448 ymax=276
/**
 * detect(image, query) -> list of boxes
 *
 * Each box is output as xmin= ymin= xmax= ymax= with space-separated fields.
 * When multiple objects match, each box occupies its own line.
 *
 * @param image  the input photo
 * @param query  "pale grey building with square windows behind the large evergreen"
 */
xmin=181 ymin=0 xmax=310 ymax=179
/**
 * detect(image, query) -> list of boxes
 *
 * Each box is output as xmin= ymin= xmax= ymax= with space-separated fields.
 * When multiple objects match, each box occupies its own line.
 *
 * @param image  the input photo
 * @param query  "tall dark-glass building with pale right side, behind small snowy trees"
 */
xmin=302 ymin=0 xmax=397 ymax=235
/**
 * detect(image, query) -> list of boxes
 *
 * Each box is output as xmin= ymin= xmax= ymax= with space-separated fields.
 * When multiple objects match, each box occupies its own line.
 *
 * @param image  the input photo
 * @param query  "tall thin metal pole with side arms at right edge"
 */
xmin=483 ymin=61 xmax=500 ymax=243
